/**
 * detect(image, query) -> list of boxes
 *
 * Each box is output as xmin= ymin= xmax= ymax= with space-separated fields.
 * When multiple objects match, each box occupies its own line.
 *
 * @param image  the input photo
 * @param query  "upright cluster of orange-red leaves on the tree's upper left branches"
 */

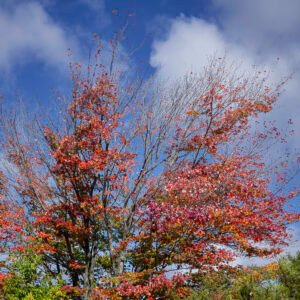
xmin=45 ymin=74 xmax=133 ymax=181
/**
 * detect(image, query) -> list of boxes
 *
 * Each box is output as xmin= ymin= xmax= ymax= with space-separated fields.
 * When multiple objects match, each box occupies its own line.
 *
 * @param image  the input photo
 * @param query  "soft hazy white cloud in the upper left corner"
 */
xmin=0 ymin=1 xmax=77 ymax=69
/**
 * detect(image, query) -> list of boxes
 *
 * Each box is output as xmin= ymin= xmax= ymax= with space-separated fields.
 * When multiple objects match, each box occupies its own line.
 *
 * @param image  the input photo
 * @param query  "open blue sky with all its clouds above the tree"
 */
xmin=0 ymin=0 xmax=300 ymax=262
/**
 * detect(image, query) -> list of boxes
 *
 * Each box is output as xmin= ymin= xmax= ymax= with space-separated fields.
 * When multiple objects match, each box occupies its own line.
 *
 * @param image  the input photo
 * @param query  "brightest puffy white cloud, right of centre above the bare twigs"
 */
xmin=150 ymin=16 xmax=253 ymax=79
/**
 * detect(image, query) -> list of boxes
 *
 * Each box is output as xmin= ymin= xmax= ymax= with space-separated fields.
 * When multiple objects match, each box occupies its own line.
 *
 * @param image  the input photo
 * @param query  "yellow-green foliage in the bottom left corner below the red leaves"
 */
xmin=0 ymin=253 xmax=65 ymax=300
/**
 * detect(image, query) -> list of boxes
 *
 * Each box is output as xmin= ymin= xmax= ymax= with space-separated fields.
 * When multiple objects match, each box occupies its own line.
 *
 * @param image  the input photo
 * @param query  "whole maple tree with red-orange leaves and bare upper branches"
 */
xmin=0 ymin=45 xmax=299 ymax=299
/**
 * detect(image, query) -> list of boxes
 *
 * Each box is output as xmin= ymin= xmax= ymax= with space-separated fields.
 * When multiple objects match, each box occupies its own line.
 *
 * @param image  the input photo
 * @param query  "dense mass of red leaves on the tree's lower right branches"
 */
xmin=135 ymin=156 xmax=299 ymax=276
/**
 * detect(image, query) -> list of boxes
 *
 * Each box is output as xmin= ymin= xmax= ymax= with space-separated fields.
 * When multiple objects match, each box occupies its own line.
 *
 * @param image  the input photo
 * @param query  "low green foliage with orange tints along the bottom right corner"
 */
xmin=189 ymin=252 xmax=300 ymax=300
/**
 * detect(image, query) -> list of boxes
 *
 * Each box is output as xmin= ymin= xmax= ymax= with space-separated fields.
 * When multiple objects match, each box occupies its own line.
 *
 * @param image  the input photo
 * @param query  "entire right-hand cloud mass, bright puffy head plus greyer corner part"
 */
xmin=150 ymin=0 xmax=300 ymax=148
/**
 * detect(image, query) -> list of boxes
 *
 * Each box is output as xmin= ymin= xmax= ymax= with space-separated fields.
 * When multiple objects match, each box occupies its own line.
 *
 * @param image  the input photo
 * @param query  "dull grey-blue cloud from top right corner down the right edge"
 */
xmin=212 ymin=0 xmax=300 ymax=149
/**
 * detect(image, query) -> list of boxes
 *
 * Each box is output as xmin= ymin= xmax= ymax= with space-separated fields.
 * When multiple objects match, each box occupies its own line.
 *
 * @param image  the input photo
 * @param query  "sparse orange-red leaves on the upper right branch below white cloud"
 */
xmin=175 ymin=83 xmax=275 ymax=162
